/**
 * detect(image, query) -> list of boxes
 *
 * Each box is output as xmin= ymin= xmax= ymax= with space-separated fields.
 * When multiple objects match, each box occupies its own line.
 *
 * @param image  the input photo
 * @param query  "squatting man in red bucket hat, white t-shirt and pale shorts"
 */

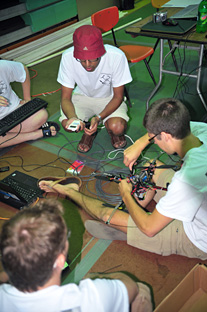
xmin=57 ymin=25 xmax=132 ymax=153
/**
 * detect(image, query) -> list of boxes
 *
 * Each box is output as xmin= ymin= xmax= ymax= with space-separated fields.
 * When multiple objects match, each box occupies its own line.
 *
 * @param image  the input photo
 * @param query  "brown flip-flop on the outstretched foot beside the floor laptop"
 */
xmin=37 ymin=176 xmax=82 ymax=193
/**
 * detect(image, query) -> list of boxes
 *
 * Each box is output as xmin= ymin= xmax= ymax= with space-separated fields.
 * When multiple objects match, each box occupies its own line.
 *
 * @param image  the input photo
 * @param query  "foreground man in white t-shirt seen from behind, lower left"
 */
xmin=0 ymin=199 xmax=152 ymax=312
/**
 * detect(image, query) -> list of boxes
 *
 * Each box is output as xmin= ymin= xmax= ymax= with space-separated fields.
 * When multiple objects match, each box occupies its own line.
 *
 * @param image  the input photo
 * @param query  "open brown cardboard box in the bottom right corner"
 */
xmin=154 ymin=264 xmax=207 ymax=312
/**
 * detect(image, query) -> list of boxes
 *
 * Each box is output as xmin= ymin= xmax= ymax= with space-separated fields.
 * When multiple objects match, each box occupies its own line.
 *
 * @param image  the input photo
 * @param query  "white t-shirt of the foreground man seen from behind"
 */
xmin=0 ymin=279 xmax=129 ymax=312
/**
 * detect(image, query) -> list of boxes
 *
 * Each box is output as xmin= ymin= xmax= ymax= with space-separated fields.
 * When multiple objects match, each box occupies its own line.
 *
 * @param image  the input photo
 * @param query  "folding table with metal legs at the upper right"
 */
xmin=125 ymin=8 xmax=207 ymax=111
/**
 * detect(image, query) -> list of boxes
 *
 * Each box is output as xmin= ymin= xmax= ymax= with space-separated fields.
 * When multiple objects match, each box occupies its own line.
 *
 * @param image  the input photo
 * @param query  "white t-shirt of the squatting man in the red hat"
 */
xmin=57 ymin=44 xmax=132 ymax=98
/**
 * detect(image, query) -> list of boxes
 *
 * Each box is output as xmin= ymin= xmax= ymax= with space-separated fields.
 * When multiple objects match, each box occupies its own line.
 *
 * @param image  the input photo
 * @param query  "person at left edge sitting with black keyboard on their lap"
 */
xmin=0 ymin=60 xmax=59 ymax=148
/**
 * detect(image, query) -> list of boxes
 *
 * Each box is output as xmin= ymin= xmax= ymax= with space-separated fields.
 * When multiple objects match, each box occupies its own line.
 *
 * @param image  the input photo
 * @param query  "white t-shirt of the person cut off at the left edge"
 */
xmin=0 ymin=60 xmax=26 ymax=119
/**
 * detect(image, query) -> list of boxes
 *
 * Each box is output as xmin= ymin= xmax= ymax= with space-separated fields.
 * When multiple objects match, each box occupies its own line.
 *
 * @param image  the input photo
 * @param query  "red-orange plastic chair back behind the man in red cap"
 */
xmin=91 ymin=6 xmax=119 ymax=33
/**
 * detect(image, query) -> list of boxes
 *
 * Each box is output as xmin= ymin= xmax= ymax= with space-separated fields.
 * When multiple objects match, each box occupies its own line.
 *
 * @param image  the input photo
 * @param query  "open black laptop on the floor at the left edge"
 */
xmin=0 ymin=170 xmax=44 ymax=210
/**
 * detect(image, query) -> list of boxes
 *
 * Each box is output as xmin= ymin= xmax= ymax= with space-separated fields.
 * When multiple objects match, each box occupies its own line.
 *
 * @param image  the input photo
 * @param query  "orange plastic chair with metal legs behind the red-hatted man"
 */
xmin=91 ymin=6 xmax=156 ymax=107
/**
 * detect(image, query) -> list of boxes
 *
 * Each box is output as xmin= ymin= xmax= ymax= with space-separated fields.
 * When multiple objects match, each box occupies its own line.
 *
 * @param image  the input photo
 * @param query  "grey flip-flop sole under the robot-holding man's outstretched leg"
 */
xmin=85 ymin=220 xmax=127 ymax=241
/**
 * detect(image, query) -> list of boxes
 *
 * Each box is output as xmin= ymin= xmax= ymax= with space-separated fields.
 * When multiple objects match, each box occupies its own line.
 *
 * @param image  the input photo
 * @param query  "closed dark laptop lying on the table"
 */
xmin=141 ymin=19 xmax=197 ymax=36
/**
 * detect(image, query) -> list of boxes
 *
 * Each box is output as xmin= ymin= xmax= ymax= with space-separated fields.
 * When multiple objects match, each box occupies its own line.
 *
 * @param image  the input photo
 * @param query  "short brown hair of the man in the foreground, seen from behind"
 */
xmin=0 ymin=200 xmax=67 ymax=292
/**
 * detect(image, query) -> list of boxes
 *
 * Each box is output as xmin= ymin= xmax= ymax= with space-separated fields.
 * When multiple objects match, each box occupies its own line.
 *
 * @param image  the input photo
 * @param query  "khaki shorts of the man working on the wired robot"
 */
xmin=127 ymin=169 xmax=207 ymax=260
